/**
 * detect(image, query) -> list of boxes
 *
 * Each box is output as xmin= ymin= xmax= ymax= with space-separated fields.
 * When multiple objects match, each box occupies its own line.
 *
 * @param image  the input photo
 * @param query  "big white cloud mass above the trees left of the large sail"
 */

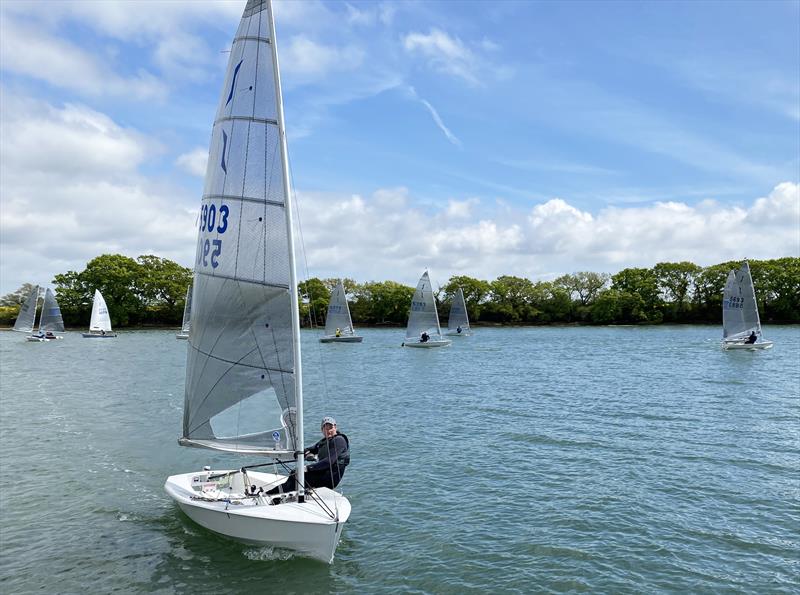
xmin=0 ymin=92 xmax=197 ymax=293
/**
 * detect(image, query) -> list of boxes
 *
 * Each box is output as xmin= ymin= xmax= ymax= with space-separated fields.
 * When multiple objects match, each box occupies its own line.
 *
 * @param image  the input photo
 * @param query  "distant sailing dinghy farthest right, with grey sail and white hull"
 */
xmin=722 ymin=260 xmax=772 ymax=349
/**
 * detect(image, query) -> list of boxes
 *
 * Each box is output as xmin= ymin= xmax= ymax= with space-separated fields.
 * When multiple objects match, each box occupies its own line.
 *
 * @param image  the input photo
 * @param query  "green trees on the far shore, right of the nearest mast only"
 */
xmin=300 ymin=258 xmax=800 ymax=325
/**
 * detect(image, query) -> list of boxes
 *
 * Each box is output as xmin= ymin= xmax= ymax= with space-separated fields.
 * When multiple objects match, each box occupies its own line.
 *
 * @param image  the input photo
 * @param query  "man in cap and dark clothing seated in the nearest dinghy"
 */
xmin=267 ymin=417 xmax=350 ymax=506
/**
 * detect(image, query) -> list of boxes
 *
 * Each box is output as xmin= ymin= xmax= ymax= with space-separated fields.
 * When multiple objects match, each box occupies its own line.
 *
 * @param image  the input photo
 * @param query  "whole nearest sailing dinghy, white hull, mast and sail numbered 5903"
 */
xmin=164 ymin=0 xmax=350 ymax=562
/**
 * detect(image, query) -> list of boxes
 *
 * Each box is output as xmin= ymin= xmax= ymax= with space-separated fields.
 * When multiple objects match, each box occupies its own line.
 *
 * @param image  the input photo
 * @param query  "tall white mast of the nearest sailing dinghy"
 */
xmin=267 ymin=0 xmax=305 ymax=502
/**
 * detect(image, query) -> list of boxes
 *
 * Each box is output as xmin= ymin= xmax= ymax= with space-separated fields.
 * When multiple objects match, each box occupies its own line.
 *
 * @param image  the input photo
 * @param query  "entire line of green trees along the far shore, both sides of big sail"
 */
xmin=0 ymin=254 xmax=800 ymax=327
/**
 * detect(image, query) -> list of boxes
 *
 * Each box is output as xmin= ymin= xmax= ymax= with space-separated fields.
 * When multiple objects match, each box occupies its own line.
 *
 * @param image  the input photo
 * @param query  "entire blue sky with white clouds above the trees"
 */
xmin=0 ymin=0 xmax=800 ymax=294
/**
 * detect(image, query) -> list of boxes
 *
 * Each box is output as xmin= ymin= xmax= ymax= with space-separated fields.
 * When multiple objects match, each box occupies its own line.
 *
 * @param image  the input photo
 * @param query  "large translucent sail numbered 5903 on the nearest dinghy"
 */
xmin=180 ymin=0 xmax=299 ymax=456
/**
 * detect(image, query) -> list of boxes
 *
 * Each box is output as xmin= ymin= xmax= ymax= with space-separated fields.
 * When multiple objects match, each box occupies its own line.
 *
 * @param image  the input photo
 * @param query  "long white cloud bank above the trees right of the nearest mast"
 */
xmin=300 ymin=183 xmax=800 ymax=285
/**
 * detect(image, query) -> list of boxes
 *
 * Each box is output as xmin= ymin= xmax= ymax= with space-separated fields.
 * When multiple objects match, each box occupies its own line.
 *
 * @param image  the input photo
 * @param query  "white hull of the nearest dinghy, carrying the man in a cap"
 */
xmin=164 ymin=471 xmax=350 ymax=563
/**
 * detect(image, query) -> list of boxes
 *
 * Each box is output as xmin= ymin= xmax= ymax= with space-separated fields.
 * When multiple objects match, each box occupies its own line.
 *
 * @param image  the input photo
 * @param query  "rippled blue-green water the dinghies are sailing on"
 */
xmin=0 ymin=326 xmax=800 ymax=593
